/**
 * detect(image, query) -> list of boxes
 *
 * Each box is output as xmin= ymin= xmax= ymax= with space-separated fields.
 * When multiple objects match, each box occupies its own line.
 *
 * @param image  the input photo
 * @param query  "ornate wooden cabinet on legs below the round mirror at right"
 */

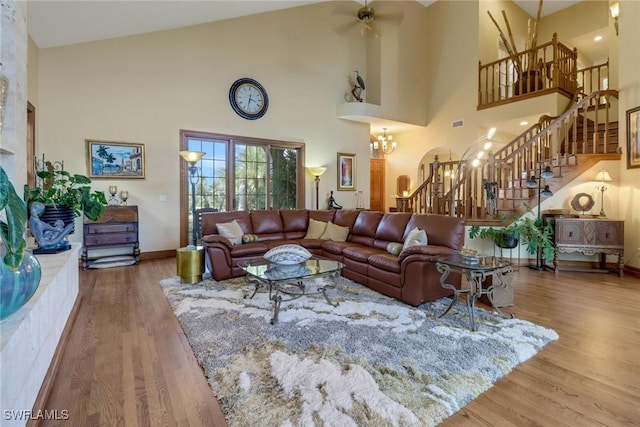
xmin=553 ymin=217 xmax=624 ymax=277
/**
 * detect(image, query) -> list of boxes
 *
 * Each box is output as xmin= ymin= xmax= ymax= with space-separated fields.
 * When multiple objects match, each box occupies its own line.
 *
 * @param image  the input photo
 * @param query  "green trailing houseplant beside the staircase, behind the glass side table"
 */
xmin=469 ymin=207 xmax=555 ymax=263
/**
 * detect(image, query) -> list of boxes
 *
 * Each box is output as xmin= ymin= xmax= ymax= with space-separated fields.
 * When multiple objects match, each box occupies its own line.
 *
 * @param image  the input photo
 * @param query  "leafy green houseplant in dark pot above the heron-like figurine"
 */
xmin=24 ymin=170 xmax=107 ymax=221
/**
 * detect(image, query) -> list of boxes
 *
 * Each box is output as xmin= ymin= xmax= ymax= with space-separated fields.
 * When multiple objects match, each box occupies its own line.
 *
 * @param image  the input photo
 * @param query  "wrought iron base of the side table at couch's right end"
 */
xmin=436 ymin=263 xmax=514 ymax=332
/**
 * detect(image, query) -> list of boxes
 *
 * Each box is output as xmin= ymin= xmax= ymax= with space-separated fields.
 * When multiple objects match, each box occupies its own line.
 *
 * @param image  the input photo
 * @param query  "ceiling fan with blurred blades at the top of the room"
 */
xmin=336 ymin=0 xmax=403 ymax=38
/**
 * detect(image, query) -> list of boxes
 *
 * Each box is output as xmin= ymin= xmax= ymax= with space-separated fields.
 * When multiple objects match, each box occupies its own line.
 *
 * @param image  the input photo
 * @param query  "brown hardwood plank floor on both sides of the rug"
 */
xmin=32 ymin=258 xmax=640 ymax=427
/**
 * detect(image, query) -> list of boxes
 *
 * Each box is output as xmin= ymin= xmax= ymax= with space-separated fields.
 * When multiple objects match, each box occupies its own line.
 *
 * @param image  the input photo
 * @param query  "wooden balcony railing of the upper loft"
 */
xmin=478 ymin=33 xmax=578 ymax=110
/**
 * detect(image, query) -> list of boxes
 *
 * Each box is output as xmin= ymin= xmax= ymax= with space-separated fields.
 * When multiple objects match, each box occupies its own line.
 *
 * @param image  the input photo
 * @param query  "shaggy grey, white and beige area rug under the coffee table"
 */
xmin=160 ymin=277 xmax=558 ymax=427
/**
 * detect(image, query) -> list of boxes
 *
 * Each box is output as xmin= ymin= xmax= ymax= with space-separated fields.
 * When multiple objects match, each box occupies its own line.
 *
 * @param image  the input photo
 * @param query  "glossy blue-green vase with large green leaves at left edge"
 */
xmin=0 ymin=166 xmax=41 ymax=319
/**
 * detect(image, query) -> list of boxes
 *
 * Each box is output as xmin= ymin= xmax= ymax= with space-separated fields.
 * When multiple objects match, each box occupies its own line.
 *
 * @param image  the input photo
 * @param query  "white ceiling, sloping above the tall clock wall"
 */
xmin=27 ymin=0 xmax=584 ymax=49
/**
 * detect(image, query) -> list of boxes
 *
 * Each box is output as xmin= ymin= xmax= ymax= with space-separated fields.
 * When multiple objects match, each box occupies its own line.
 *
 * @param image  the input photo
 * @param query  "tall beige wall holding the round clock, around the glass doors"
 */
xmin=37 ymin=3 xmax=369 ymax=252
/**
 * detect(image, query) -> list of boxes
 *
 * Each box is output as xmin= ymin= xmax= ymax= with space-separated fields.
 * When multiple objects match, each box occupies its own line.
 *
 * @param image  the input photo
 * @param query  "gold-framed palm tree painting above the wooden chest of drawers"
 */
xmin=85 ymin=139 xmax=145 ymax=179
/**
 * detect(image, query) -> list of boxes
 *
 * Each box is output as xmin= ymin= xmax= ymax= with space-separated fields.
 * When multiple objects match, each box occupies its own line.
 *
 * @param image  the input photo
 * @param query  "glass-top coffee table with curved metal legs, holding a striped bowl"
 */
xmin=238 ymin=255 xmax=344 ymax=325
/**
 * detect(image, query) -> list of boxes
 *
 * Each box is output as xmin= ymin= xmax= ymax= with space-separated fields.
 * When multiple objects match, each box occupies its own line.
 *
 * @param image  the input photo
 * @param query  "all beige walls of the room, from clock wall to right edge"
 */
xmin=30 ymin=1 xmax=640 ymax=267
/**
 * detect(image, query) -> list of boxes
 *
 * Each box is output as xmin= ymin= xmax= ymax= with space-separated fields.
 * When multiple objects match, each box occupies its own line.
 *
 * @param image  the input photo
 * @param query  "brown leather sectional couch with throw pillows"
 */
xmin=200 ymin=210 xmax=464 ymax=306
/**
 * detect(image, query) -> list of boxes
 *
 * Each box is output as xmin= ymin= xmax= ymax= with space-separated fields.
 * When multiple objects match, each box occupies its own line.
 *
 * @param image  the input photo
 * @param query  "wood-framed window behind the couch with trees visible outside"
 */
xmin=180 ymin=131 xmax=304 ymax=245
